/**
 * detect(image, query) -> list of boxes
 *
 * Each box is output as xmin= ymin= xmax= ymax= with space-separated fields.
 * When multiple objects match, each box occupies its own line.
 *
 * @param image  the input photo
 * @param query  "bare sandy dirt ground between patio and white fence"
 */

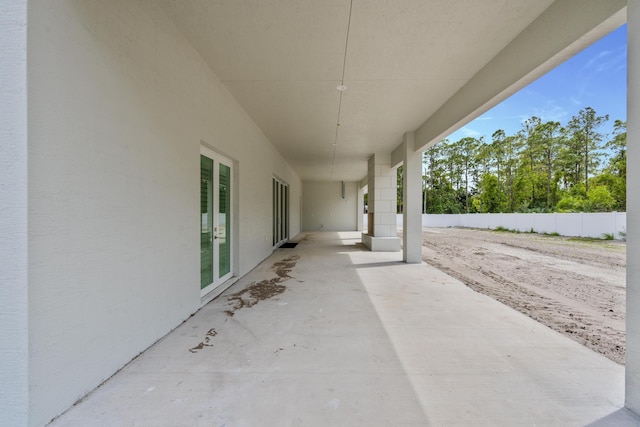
xmin=422 ymin=228 xmax=626 ymax=364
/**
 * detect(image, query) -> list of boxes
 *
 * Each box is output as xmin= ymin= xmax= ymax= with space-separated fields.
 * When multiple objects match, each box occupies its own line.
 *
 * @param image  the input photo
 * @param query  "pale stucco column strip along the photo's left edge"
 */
xmin=0 ymin=0 xmax=29 ymax=426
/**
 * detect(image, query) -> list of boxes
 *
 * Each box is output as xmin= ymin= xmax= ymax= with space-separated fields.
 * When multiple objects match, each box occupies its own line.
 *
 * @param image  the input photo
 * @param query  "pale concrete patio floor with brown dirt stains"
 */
xmin=51 ymin=232 xmax=640 ymax=427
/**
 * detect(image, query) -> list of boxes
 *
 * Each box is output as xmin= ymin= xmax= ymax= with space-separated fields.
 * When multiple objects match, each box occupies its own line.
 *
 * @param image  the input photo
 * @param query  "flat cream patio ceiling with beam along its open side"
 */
xmin=160 ymin=0 xmax=626 ymax=181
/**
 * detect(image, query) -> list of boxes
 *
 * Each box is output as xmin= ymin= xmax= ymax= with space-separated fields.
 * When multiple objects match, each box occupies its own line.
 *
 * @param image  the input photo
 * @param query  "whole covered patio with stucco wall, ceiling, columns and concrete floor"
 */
xmin=0 ymin=0 xmax=640 ymax=426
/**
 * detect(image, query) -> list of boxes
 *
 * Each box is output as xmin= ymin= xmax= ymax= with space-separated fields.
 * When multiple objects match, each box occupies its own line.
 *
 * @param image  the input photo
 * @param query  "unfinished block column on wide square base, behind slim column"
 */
xmin=362 ymin=153 xmax=400 ymax=252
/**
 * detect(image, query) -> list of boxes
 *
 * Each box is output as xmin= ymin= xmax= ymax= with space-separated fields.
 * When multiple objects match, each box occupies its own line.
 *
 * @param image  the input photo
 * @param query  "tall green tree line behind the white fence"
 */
xmin=398 ymin=107 xmax=627 ymax=213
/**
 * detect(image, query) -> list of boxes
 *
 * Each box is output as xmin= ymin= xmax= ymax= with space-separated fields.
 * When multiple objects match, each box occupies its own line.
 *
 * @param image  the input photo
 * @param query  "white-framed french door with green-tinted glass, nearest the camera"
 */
xmin=200 ymin=147 xmax=233 ymax=295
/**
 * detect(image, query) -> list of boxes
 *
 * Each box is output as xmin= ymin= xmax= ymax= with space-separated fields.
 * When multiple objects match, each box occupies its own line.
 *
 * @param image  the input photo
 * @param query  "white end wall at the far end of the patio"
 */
xmin=302 ymin=181 xmax=358 ymax=231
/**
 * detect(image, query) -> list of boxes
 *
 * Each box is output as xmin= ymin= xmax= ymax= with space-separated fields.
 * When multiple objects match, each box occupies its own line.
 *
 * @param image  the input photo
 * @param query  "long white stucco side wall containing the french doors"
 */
xmin=28 ymin=0 xmax=302 ymax=425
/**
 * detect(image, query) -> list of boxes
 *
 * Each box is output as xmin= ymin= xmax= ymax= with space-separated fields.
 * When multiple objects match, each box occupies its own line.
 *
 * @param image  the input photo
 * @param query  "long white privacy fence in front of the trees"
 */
xmin=365 ymin=212 xmax=627 ymax=239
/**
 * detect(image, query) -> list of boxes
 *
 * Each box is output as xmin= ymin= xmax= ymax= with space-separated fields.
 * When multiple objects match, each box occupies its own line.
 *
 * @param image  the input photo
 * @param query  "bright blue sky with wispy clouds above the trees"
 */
xmin=448 ymin=25 xmax=627 ymax=142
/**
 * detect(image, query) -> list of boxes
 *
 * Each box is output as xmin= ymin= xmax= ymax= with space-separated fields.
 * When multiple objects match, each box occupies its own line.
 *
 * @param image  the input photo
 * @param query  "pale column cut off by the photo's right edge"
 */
xmin=625 ymin=0 xmax=640 ymax=414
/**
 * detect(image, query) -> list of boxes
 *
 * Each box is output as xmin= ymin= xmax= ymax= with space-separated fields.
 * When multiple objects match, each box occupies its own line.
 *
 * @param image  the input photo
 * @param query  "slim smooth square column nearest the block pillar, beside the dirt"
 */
xmin=402 ymin=132 xmax=422 ymax=263
